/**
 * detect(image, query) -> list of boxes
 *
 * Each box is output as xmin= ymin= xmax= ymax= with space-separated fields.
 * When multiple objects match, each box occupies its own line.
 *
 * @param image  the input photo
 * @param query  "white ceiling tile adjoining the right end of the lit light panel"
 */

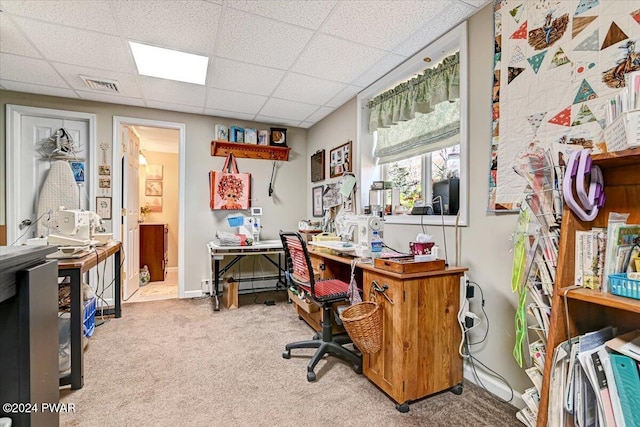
xmin=207 ymin=58 xmax=285 ymax=95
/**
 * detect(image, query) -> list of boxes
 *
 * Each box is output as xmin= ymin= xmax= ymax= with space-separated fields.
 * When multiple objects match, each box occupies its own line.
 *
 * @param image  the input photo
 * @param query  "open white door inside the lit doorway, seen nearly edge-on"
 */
xmin=121 ymin=126 xmax=140 ymax=300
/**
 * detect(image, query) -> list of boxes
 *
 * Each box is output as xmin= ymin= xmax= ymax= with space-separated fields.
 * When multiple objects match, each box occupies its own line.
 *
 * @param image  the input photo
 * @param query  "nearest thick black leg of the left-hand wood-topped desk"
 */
xmin=68 ymin=269 xmax=84 ymax=390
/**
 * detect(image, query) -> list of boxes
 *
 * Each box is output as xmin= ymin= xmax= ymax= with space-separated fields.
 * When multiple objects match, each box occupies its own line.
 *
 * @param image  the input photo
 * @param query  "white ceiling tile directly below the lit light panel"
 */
xmin=138 ymin=76 xmax=207 ymax=108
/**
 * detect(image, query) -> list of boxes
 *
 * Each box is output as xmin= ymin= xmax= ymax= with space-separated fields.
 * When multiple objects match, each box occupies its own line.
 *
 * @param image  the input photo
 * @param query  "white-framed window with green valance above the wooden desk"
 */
xmin=356 ymin=23 xmax=468 ymax=225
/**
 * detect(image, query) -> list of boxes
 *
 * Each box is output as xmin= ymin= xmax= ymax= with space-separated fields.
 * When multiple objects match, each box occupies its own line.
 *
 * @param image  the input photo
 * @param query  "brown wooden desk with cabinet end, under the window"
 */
xmin=309 ymin=250 xmax=467 ymax=412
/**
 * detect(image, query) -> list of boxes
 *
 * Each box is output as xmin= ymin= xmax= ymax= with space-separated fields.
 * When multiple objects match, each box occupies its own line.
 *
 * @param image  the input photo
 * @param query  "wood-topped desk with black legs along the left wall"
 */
xmin=58 ymin=242 xmax=122 ymax=390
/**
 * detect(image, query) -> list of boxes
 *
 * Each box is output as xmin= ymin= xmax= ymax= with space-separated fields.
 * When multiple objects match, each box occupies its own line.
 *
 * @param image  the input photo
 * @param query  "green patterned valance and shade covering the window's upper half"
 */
xmin=367 ymin=52 xmax=460 ymax=163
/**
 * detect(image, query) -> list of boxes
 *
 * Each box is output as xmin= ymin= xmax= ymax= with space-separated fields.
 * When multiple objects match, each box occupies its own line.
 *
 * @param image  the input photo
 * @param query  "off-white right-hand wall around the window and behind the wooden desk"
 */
xmin=307 ymin=5 xmax=532 ymax=398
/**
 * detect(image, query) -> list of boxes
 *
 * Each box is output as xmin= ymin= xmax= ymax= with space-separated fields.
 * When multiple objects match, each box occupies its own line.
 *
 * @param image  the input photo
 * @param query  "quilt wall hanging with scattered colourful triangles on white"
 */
xmin=489 ymin=0 xmax=640 ymax=211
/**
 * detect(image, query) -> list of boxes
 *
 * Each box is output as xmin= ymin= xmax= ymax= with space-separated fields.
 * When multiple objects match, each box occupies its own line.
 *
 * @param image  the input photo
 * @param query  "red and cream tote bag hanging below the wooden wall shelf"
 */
xmin=209 ymin=154 xmax=251 ymax=210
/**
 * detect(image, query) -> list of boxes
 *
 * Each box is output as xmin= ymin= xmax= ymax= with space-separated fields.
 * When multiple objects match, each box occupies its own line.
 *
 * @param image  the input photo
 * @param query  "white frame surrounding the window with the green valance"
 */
xmin=354 ymin=21 xmax=469 ymax=226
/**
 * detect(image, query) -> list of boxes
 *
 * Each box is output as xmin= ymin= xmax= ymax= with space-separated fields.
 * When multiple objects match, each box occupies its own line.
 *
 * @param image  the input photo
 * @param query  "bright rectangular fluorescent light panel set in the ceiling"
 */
xmin=129 ymin=41 xmax=209 ymax=85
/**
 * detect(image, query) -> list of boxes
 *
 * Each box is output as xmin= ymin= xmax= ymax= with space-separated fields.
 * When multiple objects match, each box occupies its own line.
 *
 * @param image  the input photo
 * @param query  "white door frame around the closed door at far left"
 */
xmin=5 ymin=104 xmax=98 ymax=245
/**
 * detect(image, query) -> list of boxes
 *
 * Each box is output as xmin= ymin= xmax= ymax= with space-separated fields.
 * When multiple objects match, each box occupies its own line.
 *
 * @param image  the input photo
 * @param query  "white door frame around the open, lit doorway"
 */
xmin=111 ymin=116 xmax=186 ymax=298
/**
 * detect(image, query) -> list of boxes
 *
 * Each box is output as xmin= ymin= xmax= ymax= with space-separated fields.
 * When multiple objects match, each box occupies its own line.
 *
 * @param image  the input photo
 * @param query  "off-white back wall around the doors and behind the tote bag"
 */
xmin=0 ymin=91 xmax=309 ymax=296
